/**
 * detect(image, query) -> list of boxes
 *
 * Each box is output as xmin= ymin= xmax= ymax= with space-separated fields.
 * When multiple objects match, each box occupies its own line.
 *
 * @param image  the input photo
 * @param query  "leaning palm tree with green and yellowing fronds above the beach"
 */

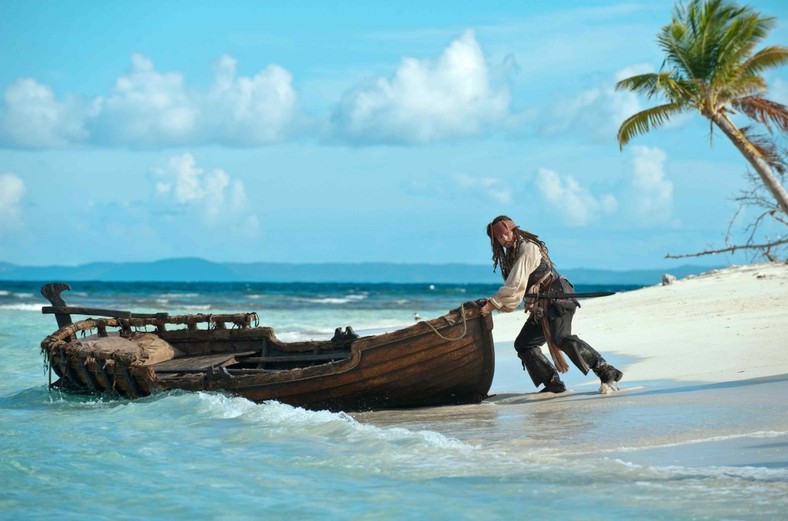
xmin=616 ymin=0 xmax=788 ymax=214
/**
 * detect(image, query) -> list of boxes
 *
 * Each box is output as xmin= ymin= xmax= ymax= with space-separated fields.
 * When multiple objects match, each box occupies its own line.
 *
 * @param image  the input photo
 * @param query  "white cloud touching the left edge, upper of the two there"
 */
xmin=0 ymin=78 xmax=86 ymax=148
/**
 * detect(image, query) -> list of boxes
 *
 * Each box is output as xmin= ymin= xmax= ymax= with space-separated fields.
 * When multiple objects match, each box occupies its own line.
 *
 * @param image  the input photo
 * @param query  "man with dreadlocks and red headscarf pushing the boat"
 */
xmin=482 ymin=215 xmax=624 ymax=394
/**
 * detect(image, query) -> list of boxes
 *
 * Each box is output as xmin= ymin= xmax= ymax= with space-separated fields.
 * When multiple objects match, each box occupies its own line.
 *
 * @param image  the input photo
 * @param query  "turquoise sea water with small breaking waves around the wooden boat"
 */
xmin=0 ymin=282 xmax=788 ymax=520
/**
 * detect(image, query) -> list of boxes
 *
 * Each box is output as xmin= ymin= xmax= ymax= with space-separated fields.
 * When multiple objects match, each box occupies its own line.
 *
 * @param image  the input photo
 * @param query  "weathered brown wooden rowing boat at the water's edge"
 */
xmin=41 ymin=283 xmax=495 ymax=411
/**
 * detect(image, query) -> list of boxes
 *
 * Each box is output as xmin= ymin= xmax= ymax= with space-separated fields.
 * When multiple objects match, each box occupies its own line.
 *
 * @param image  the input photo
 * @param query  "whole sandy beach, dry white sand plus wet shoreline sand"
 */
xmin=363 ymin=263 xmax=788 ymax=472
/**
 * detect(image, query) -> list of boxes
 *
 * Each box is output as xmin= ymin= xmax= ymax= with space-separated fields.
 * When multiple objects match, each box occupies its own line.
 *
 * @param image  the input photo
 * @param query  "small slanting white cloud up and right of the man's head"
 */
xmin=536 ymin=168 xmax=618 ymax=226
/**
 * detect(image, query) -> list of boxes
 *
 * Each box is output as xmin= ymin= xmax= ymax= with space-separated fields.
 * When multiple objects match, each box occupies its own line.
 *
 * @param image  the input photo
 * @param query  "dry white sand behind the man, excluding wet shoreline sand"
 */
xmin=493 ymin=263 xmax=788 ymax=392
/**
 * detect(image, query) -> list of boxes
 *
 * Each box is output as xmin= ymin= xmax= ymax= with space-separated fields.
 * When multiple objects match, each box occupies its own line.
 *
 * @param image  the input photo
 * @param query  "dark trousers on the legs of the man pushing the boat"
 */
xmin=514 ymin=300 xmax=607 ymax=387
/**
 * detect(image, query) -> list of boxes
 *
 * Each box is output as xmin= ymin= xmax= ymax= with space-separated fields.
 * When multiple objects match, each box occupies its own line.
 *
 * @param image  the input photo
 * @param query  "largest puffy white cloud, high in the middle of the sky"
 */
xmin=333 ymin=31 xmax=509 ymax=143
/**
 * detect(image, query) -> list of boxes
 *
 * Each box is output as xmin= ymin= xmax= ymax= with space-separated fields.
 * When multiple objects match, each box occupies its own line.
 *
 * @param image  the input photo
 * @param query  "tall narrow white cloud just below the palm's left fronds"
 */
xmin=632 ymin=146 xmax=673 ymax=224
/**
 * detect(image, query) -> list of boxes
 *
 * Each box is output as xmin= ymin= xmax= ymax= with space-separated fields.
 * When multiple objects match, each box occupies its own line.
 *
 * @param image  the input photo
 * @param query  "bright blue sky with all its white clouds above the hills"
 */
xmin=0 ymin=0 xmax=788 ymax=269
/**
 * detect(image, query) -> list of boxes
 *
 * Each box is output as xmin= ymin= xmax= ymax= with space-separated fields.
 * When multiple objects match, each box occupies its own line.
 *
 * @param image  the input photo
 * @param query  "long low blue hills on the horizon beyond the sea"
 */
xmin=0 ymin=258 xmax=714 ymax=286
